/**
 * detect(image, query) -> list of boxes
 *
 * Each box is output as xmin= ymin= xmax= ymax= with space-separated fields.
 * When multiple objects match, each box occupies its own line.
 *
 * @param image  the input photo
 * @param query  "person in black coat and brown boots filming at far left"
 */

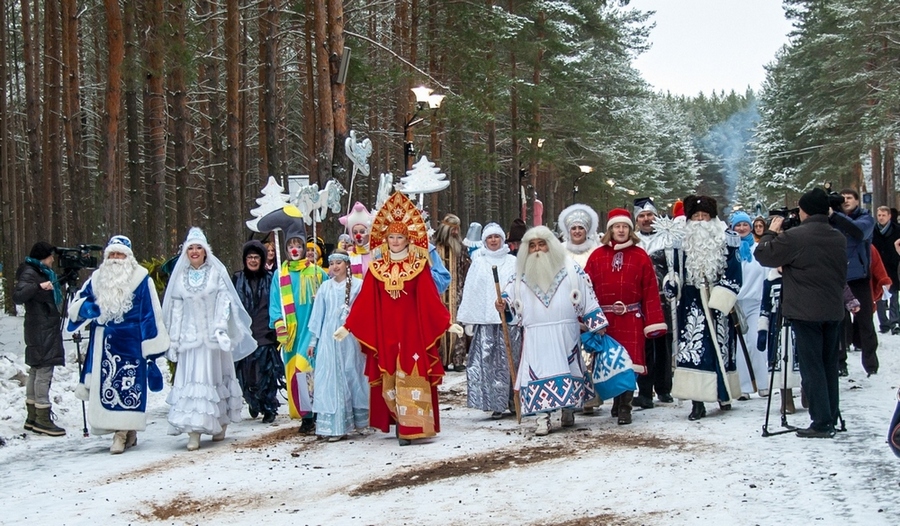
xmin=13 ymin=241 xmax=66 ymax=436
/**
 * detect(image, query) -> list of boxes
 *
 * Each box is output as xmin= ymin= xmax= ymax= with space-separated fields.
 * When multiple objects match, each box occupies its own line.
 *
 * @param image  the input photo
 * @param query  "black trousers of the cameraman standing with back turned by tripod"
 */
xmin=791 ymin=320 xmax=844 ymax=431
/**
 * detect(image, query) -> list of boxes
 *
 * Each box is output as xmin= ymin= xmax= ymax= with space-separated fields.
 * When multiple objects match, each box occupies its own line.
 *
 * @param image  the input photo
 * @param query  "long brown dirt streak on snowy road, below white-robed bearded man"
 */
xmin=348 ymin=433 xmax=698 ymax=498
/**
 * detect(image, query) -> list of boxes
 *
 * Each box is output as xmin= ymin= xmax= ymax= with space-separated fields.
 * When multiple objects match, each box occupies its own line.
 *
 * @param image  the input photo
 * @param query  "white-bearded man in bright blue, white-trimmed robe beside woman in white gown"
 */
xmin=69 ymin=236 xmax=169 ymax=454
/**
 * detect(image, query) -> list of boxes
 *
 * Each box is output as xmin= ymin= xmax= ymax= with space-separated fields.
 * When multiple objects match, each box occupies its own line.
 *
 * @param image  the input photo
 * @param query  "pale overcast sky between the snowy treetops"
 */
xmin=630 ymin=0 xmax=791 ymax=96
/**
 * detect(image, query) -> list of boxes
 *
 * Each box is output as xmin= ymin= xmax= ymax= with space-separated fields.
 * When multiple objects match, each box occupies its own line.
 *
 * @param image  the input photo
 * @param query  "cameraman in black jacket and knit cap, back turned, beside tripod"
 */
xmin=754 ymin=188 xmax=848 ymax=438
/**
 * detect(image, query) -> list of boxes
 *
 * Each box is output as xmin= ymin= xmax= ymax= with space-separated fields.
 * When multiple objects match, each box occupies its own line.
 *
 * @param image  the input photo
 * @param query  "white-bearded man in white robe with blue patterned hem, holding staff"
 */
xmin=496 ymin=226 xmax=607 ymax=436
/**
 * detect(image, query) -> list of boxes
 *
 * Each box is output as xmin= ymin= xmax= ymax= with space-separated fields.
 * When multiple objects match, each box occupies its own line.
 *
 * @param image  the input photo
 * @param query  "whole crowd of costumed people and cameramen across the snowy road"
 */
xmin=14 ymin=188 xmax=884 ymax=454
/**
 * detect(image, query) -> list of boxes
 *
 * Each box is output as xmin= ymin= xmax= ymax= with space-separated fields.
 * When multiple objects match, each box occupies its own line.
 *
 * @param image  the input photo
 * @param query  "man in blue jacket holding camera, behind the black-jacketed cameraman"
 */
xmin=830 ymin=188 xmax=878 ymax=376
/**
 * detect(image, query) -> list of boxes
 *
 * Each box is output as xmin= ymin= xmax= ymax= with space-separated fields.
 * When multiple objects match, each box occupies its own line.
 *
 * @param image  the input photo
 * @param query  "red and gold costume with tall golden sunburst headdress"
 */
xmin=344 ymin=192 xmax=450 ymax=439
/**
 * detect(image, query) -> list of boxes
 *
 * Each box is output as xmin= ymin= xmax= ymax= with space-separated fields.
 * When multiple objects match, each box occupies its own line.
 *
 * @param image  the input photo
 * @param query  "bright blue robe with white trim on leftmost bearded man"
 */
xmin=67 ymin=267 xmax=169 ymax=435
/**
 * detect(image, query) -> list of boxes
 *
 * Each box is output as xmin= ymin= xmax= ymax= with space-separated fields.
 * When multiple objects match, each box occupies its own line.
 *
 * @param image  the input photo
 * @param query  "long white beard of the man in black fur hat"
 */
xmin=682 ymin=218 xmax=728 ymax=285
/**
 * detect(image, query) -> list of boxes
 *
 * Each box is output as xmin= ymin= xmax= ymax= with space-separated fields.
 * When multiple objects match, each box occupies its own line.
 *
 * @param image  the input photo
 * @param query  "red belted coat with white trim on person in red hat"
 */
xmin=584 ymin=241 xmax=667 ymax=374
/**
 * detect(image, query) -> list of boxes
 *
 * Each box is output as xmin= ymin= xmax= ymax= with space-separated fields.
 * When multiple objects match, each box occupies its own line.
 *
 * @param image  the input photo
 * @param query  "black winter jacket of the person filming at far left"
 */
xmin=13 ymin=263 xmax=66 ymax=367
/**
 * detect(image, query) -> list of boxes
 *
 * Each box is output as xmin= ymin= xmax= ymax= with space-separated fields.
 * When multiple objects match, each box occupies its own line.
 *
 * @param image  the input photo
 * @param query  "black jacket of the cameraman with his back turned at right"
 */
xmin=753 ymin=214 xmax=847 ymax=321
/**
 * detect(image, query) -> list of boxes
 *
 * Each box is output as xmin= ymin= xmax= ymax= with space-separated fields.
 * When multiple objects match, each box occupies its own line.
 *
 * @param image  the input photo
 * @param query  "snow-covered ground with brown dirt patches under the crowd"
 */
xmin=0 ymin=317 xmax=900 ymax=526
